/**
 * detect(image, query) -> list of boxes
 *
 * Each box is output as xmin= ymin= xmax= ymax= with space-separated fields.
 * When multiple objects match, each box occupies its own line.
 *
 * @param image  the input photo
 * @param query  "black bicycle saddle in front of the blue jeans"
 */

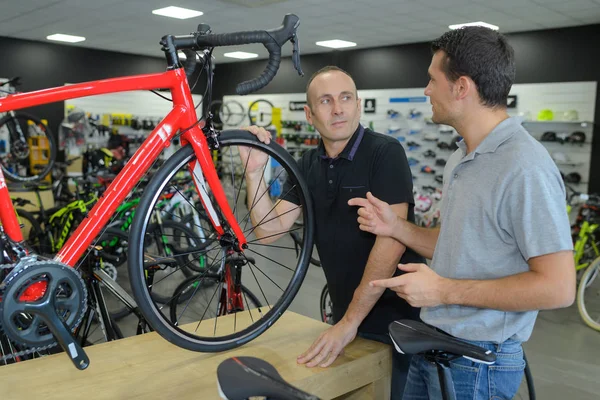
xmin=388 ymin=319 xmax=496 ymax=364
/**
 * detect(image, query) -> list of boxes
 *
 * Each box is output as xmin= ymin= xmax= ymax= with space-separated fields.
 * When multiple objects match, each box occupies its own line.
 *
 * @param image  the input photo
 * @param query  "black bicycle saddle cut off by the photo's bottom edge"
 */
xmin=217 ymin=357 xmax=319 ymax=400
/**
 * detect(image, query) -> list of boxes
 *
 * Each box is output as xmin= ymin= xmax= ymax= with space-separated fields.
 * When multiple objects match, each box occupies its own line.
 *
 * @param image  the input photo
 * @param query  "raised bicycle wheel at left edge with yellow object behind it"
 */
xmin=0 ymin=112 xmax=57 ymax=182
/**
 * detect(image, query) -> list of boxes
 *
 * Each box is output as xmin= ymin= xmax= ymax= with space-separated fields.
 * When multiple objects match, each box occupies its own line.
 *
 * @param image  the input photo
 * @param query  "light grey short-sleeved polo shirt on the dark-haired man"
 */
xmin=421 ymin=118 xmax=573 ymax=343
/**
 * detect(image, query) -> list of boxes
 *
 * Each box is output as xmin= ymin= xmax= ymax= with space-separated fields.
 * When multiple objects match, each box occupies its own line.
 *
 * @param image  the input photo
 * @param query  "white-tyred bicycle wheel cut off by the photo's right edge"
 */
xmin=577 ymin=257 xmax=600 ymax=331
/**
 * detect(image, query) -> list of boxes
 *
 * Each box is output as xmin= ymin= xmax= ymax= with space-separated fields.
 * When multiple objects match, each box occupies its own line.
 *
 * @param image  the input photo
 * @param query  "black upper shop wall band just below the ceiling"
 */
xmin=0 ymin=25 xmax=600 ymax=191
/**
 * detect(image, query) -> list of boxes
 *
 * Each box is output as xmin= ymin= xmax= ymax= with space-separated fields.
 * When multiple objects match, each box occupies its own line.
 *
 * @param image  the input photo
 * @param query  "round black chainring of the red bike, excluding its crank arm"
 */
xmin=0 ymin=261 xmax=87 ymax=347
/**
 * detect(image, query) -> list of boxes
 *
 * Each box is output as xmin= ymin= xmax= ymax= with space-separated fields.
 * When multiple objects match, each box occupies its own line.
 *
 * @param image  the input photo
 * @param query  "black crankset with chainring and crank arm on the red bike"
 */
xmin=0 ymin=261 xmax=89 ymax=369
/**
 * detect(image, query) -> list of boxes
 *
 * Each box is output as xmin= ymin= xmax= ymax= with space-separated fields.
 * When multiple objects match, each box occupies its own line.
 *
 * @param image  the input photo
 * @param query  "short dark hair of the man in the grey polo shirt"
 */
xmin=431 ymin=26 xmax=515 ymax=107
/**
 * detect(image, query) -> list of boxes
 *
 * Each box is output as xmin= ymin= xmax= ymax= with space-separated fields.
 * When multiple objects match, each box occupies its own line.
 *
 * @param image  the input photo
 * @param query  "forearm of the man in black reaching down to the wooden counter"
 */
xmin=344 ymin=236 xmax=406 ymax=327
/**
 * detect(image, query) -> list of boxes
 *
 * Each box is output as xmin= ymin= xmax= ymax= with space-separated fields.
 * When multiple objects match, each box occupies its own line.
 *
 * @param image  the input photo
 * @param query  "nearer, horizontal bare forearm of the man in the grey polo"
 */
xmin=442 ymin=271 xmax=574 ymax=312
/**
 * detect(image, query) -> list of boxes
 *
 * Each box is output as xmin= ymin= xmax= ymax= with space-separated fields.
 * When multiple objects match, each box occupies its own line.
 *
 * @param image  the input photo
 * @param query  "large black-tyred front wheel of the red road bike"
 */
xmin=129 ymin=130 xmax=314 ymax=352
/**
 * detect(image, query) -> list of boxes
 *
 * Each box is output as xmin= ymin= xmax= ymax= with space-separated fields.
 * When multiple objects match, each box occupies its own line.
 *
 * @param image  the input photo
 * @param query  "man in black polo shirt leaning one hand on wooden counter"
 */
xmin=240 ymin=67 xmax=424 ymax=398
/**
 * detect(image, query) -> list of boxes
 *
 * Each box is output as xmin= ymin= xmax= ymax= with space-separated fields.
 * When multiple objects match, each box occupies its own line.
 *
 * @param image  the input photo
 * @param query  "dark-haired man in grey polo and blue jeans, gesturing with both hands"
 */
xmin=349 ymin=27 xmax=575 ymax=400
